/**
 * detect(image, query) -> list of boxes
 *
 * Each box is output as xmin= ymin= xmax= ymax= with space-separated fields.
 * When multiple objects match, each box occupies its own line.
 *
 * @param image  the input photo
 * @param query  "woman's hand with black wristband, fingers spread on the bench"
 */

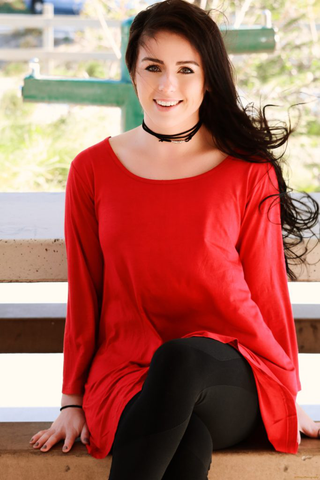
xmin=30 ymin=396 xmax=89 ymax=453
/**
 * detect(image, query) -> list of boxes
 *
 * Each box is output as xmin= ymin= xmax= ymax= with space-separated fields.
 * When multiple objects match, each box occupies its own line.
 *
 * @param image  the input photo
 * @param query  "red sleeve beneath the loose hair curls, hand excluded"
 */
xmin=236 ymin=164 xmax=301 ymax=396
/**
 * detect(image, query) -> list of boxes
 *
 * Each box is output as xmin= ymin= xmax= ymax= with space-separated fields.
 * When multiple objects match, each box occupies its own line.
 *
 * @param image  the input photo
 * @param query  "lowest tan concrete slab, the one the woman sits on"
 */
xmin=0 ymin=422 xmax=320 ymax=480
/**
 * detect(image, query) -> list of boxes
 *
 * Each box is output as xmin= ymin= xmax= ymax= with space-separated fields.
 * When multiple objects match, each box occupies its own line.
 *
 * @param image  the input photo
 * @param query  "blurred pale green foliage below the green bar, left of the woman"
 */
xmin=0 ymin=90 xmax=120 ymax=192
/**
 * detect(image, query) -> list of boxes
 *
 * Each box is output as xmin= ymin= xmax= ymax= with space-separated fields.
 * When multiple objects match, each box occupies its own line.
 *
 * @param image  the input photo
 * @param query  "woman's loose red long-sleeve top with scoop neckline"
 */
xmin=62 ymin=138 xmax=301 ymax=458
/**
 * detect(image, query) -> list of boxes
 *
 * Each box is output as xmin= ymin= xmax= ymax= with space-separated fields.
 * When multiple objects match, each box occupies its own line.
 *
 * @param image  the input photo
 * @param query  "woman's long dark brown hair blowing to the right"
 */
xmin=125 ymin=0 xmax=319 ymax=280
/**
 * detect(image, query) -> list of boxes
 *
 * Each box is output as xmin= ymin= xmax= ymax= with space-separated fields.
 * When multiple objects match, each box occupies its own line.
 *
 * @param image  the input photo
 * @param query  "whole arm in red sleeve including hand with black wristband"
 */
xmin=30 ymin=150 xmax=104 ymax=452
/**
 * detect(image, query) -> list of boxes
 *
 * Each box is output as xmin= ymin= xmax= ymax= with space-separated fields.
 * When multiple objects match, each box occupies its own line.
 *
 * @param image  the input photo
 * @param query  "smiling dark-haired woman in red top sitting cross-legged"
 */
xmin=31 ymin=0 xmax=319 ymax=480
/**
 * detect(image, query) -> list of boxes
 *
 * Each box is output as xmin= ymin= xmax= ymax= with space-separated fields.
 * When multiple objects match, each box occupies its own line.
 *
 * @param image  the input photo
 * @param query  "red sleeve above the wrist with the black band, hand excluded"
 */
xmin=62 ymin=158 xmax=104 ymax=395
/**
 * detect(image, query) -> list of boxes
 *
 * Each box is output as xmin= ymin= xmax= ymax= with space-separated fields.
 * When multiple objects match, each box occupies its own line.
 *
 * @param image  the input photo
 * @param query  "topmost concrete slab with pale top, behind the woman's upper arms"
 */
xmin=0 ymin=192 xmax=320 ymax=282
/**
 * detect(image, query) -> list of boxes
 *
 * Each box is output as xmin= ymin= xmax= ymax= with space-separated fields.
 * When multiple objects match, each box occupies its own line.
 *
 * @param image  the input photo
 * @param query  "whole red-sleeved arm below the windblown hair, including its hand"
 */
xmin=237 ymin=165 xmax=320 ymax=444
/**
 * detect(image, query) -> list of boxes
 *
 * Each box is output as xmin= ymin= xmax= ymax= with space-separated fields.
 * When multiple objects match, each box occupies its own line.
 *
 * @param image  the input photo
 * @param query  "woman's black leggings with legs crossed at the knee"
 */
xmin=109 ymin=337 xmax=261 ymax=480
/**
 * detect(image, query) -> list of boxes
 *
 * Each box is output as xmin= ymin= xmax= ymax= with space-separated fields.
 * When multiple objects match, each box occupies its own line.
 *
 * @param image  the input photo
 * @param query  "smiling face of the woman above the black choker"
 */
xmin=133 ymin=31 xmax=206 ymax=134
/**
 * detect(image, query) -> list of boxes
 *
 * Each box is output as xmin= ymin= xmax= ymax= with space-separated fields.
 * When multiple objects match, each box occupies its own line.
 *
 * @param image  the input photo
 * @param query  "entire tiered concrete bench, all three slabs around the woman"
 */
xmin=0 ymin=193 xmax=320 ymax=480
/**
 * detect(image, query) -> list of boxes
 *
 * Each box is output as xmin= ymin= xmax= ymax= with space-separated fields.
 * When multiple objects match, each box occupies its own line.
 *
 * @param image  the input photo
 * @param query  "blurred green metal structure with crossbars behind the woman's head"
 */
xmin=22 ymin=17 xmax=276 ymax=131
